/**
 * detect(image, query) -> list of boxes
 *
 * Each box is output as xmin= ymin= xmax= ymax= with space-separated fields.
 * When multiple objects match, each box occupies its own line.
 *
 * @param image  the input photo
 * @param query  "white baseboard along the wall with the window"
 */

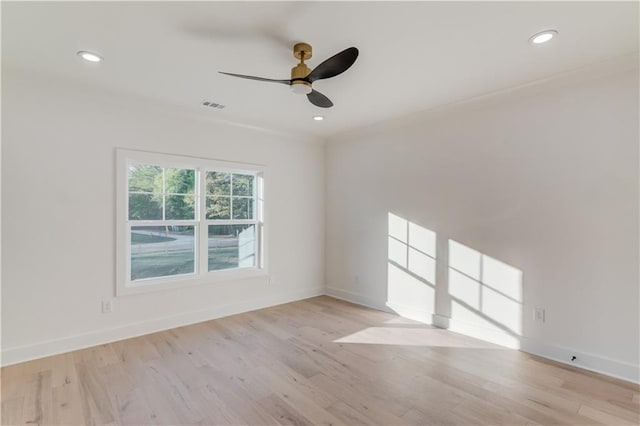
xmin=2 ymin=287 xmax=325 ymax=366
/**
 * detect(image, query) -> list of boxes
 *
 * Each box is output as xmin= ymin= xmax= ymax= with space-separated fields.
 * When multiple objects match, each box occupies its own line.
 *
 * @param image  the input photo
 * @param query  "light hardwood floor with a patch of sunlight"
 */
xmin=2 ymin=297 xmax=640 ymax=425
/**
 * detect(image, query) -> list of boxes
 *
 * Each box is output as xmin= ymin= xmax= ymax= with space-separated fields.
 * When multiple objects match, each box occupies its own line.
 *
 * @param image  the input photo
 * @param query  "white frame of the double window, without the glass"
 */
xmin=116 ymin=149 xmax=267 ymax=296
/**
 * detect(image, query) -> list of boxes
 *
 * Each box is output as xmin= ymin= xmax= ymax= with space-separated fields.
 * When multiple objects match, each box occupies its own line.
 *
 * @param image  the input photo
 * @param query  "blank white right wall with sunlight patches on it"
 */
xmin=325 ymin=58 xmax=640 ymax=381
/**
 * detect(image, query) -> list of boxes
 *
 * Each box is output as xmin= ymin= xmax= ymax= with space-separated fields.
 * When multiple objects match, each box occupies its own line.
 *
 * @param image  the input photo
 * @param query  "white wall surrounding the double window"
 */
xmin=2 ymin=69 xmax=324 ymax=365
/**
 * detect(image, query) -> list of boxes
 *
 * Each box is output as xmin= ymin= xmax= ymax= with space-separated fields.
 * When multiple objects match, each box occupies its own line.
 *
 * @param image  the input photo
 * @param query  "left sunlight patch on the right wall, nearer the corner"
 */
xmin=387 ymin=213 xmax=436 ymax=322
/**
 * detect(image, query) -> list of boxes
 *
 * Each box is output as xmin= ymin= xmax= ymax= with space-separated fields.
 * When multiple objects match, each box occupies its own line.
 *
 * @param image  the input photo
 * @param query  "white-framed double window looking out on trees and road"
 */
xmin=117 ymin=150 xmax=264 ymax=294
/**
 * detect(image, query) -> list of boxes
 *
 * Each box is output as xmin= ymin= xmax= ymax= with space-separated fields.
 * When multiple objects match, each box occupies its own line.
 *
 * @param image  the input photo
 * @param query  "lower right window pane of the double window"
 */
xmin=208 ymin=225 xmax=256 ymax=271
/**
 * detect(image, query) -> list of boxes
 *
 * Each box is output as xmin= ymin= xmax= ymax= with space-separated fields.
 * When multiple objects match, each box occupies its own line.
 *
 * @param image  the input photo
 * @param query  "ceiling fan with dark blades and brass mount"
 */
xmin=219 ymin=43 xmax=358 ymax=108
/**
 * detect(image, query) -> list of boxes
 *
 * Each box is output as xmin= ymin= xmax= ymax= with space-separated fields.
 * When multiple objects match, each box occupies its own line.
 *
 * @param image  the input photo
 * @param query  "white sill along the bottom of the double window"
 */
xmin=116 ymin=268 xmax=269 ymax=297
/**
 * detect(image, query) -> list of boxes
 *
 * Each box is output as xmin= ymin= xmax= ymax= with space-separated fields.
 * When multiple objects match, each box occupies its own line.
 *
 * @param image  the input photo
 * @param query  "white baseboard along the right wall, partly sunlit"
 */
xmin=326 ymin=288 xmax=640 ymax=383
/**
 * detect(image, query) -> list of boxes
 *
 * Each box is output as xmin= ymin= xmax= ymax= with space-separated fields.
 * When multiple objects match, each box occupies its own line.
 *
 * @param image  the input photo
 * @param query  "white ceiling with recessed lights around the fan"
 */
xmin=2 ymin=2 xmax=638 ymax=135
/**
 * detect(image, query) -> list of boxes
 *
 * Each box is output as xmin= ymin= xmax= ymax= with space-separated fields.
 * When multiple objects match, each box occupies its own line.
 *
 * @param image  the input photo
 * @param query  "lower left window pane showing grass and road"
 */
xmin=130 ymin=226 xmax=195 ymax=281
